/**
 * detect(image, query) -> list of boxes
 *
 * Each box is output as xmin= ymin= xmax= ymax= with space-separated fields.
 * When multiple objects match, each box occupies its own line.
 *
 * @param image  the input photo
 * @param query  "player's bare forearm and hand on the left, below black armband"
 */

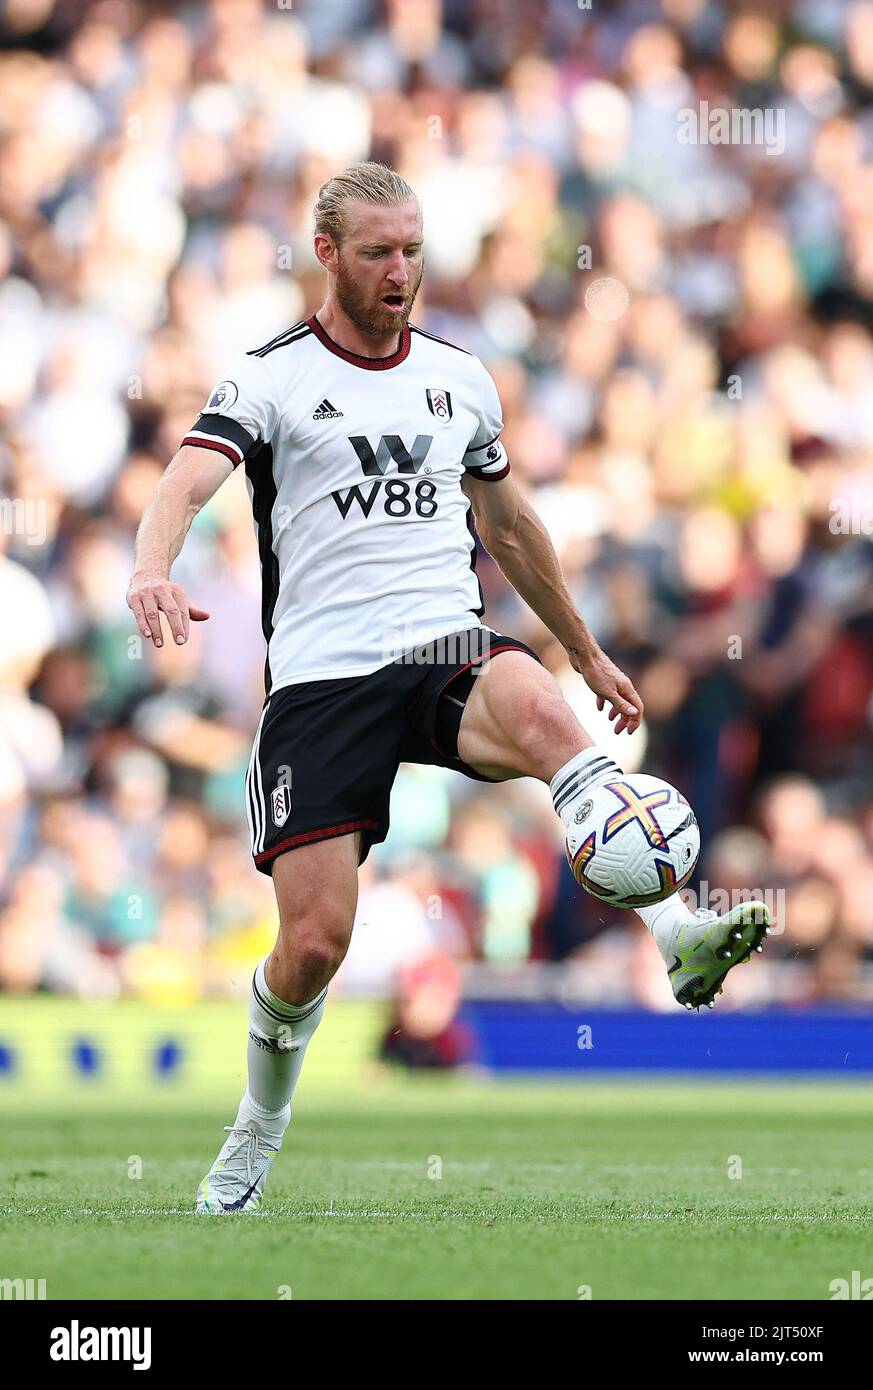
xmin=128 ymin=443 xmax=234 ymax=646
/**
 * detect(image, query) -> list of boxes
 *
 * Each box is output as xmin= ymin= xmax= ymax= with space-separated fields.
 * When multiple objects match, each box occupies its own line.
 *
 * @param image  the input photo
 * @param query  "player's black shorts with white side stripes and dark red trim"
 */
xmin=246 ymin=628 xmax=539 ymax=874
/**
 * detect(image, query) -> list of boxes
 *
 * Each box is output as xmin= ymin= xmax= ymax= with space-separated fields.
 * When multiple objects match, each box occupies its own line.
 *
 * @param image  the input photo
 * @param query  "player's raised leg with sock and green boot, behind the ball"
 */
xmin=457 ymin=652 xmax=769 ymax=1008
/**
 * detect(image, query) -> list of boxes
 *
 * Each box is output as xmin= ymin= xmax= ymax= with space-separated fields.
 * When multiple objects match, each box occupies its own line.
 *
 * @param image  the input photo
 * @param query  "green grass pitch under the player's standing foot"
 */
xmin=0 ymin=1079 xmax=873 ymax=1300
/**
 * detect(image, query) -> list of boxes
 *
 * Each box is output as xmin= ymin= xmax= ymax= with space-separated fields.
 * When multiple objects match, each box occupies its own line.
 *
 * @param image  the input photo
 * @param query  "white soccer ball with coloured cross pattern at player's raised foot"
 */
xmin=566 ymin=773 xmax=701 ymax=908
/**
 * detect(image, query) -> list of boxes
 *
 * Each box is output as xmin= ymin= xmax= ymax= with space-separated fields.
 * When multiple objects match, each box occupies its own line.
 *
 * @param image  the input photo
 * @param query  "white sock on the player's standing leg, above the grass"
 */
xmin=235 ymin=960 xmax=327 ymax=1143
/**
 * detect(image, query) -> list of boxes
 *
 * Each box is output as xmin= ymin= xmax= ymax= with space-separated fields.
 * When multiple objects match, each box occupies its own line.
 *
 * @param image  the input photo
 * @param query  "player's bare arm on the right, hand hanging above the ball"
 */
xmin=462 ymin=464 xmax=642 ymax=734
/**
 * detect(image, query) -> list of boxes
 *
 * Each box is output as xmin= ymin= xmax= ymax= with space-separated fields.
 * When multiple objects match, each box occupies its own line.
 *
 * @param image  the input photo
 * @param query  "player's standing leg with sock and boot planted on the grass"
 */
xmin=196 ymin=831 xmax=360 ymax=1215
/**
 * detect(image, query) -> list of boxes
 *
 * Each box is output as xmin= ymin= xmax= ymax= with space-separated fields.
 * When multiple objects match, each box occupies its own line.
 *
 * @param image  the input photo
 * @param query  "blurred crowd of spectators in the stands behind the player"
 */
xmin=0 ymin=0 xmax=873 ymax=1022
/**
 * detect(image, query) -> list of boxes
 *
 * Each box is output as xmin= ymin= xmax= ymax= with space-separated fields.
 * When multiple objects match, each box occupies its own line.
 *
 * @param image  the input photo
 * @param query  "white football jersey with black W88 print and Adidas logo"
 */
xmin=182 ymin=316 xmax=509 ymax=694
